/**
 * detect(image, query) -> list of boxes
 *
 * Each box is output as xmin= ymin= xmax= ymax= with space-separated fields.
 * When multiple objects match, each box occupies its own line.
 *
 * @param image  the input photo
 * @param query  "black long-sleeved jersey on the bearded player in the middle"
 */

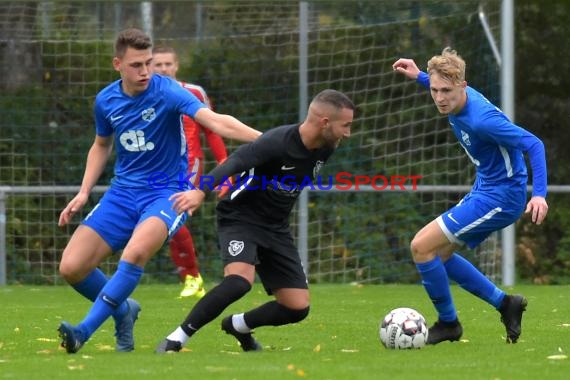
xmin=208 ymin=124 xmax=334 ymax=229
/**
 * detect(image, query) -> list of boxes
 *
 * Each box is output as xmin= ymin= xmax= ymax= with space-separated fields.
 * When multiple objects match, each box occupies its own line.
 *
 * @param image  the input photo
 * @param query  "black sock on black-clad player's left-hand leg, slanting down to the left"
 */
xmin=180 ymin=275 xmax=251 ymax=336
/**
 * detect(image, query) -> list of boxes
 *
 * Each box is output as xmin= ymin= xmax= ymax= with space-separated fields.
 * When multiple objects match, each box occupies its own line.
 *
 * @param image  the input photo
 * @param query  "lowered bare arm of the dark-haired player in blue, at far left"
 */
xmin=58 ymin=136 xmax=113 ymax=227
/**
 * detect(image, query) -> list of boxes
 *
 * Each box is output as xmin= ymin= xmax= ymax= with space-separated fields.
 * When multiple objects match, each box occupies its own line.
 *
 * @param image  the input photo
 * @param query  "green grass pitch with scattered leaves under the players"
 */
xmin=0 ymin=284 xmax=570 ymax=380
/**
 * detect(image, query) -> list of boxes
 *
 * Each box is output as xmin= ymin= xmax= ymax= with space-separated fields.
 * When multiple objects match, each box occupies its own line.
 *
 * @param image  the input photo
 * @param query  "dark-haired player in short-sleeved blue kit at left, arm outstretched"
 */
xmin=58 ymin=29 xmax=260 ymax=353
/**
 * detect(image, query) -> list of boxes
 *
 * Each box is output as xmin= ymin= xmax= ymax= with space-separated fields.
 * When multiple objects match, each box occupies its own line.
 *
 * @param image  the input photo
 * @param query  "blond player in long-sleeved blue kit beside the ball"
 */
xmin=393 ymin=48 xmax=548 ymax=344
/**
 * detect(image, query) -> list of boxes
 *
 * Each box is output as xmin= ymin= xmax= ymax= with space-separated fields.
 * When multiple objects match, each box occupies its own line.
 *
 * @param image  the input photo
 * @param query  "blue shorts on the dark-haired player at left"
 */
xmin=82 ymin=186 xmax=187 ymax=252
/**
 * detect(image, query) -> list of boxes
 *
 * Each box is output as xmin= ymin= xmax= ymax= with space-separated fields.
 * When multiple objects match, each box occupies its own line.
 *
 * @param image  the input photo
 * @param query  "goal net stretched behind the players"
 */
xmin=0 ymin=0 xmax=500 ymax=283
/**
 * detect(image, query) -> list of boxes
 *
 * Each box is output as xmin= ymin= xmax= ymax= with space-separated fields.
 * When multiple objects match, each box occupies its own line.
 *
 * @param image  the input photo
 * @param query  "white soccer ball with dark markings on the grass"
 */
xmin=380 ymin=307 xmax=428 ymax=350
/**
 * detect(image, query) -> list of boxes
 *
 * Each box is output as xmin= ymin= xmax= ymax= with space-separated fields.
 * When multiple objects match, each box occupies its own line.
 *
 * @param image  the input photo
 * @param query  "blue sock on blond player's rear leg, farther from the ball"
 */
xmin=444 ymin=252 xmax=505 ymax=309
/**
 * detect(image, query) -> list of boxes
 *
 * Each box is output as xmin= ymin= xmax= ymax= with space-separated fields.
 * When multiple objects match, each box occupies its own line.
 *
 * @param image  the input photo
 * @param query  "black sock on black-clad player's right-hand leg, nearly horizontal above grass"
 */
xmin=243 ymin=301 xmax=309 ymax=329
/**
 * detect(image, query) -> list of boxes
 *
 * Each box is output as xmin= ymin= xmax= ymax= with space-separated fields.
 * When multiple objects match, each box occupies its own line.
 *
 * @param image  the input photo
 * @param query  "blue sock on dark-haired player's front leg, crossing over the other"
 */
xmin=77 ymin=260 xmax=143 ymax=339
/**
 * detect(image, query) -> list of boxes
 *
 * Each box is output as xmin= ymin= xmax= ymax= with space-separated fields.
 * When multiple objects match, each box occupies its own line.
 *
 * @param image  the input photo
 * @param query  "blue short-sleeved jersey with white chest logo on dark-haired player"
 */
xmin=95 ymin=74 xmax=205 ymax=188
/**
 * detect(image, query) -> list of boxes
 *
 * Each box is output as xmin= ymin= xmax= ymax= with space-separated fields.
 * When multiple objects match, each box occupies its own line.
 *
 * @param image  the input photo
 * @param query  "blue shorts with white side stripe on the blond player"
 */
xmin=436 ymin=185 xmax=526 ymax=248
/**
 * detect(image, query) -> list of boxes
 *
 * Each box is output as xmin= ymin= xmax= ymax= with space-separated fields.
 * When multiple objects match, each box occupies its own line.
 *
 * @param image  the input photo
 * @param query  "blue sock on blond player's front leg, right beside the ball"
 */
xmin=416 ymin=256 xmax=457 ymax=322
